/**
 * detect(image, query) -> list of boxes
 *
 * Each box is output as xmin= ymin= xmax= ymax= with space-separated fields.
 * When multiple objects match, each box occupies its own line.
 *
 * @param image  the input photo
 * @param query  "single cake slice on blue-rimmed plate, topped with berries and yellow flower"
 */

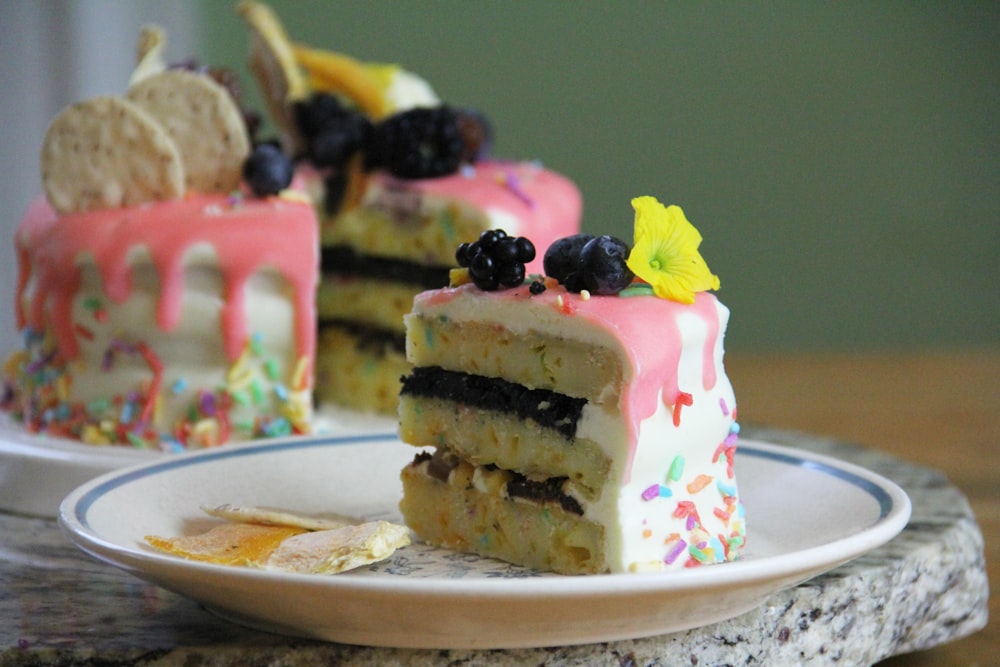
xmin=399 ymin=197 xmax=745 ymax=574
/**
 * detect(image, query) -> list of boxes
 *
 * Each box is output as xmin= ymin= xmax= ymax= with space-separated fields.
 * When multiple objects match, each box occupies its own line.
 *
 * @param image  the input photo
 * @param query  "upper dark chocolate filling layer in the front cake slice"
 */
xmin=401 ymin=366 xmax=587 ymax=440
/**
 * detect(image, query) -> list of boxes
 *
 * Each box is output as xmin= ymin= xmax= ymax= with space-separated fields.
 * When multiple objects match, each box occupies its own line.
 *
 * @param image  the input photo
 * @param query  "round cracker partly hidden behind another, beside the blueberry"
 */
xmin=125 ymin=70 xmax=250 ymax=192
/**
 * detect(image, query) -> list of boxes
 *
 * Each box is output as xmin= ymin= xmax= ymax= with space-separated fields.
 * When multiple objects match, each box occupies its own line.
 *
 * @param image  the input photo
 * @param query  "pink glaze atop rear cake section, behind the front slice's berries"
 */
xmin=372 ymin=160 xmax=583 ymax=273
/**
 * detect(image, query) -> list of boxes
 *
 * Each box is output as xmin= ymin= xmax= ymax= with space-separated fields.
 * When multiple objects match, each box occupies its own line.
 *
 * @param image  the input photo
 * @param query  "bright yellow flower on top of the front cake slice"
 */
xmin=627 ymin=197 xmax=719 ymax=303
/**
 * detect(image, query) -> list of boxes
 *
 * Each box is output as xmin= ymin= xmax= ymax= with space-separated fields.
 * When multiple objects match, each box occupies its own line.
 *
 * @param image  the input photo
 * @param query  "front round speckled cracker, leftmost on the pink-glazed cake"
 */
xmin=41 ymin=97 xmax=184 ymax=213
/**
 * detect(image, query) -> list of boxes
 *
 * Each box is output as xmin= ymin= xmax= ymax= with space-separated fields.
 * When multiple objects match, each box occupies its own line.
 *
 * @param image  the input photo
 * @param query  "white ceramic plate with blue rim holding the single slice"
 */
xmin=60 ymin=435 xmax=910 ymax=648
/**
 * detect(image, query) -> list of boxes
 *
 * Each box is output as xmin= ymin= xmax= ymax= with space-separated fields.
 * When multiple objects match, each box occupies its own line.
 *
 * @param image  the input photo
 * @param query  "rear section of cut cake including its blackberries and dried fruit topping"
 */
xmin=241 ymin=3 xmax=581 ymax=414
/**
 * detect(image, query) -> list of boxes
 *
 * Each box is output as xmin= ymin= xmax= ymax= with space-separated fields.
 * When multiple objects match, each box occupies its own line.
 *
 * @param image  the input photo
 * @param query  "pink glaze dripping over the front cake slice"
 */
xmin=414 ymin=284 xmax=722 ymax=477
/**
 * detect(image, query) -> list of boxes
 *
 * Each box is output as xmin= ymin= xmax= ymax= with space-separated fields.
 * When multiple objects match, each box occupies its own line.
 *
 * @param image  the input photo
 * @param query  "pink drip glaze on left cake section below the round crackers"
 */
xmin=15 ymin=194 xmax=318 ymax=360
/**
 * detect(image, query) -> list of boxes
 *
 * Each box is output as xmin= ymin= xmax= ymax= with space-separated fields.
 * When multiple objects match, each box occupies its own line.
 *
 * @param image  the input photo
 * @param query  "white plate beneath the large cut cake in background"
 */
xmin=0 ymin=408 xmax=396 ymax=518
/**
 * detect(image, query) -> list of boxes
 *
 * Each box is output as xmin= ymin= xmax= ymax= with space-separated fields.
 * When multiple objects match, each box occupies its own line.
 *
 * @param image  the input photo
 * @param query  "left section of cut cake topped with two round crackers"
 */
xmin=3 ymin=28 xmax=318 ymax=450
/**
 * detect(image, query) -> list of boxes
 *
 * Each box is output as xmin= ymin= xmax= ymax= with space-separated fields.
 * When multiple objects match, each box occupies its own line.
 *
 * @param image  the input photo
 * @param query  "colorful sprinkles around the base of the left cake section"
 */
xmin=0 ymin=326 xmax=312 ymax=452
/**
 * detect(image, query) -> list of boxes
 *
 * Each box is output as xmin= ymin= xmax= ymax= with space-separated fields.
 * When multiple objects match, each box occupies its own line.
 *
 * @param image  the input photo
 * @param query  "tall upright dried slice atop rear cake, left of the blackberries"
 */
xmin=236 ymin=0 xmax=309 ymax=155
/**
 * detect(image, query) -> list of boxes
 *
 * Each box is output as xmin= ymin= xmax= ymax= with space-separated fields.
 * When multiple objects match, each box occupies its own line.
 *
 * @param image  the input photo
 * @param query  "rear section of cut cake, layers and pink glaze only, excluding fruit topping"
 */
xmin=316 ymin=162 xmax=581 ymax=413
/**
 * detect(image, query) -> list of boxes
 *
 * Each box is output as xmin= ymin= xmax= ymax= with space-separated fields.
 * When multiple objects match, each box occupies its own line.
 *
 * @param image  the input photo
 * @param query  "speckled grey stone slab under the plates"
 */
xmin=0 ymin=428 xmax=989 ymax=667
